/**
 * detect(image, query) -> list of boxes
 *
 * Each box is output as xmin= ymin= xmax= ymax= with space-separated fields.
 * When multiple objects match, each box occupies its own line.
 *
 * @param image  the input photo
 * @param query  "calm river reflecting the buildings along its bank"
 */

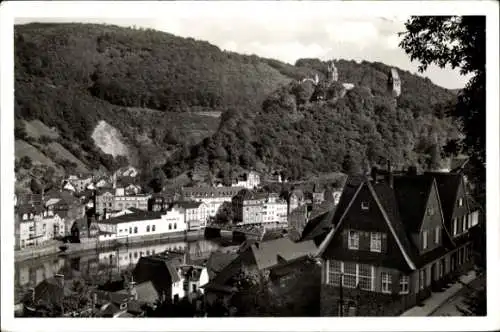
xmin=14 ymin=238 xmax=234 ymax=299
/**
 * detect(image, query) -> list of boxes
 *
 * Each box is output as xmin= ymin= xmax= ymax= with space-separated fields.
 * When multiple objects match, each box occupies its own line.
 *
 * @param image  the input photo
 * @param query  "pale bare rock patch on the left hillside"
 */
xmin=92 ymin=120 xmax=129 ymax=157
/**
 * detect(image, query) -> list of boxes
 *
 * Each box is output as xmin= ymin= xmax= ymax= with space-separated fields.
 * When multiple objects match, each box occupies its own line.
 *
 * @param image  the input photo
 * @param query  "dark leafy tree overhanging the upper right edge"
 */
xmin=399 ymin=16 xmax=486 ymax=203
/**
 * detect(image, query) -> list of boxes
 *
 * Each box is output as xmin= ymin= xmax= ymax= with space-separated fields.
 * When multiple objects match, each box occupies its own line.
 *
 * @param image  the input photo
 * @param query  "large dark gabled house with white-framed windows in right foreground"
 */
xmin=317 ymin=167 xmax=472 ymax=316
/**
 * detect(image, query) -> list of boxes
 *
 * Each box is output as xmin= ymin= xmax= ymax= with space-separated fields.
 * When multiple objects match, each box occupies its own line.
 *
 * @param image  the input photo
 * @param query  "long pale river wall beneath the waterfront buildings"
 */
xmin=14 ymin=229 xmax=204 ymax=262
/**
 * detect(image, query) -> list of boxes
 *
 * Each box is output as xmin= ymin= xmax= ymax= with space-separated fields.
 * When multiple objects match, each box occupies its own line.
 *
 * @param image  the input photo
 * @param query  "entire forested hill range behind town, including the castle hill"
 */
xmin=15 ymin=23 xmax=457 ymax=189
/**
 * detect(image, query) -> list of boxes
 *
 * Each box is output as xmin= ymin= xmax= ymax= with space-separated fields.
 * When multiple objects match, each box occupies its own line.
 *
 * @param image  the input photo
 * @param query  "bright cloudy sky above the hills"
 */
xmin=15 ymin=6 xmax=470 ymax=89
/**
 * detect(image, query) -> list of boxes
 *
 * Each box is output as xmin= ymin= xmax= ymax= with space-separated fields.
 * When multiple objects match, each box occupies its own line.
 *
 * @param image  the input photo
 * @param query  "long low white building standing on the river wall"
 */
xmin=97 ymin=208 xmax=187 ymax=241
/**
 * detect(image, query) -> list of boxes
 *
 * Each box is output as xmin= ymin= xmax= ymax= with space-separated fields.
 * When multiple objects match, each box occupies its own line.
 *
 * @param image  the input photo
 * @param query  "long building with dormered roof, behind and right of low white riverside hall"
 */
xmin=181 ymin=187 xmax=244 ymax=217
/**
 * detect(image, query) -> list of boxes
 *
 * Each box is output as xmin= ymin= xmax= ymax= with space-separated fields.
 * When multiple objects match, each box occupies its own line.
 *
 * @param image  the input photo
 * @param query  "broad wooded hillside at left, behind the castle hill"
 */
xmin=14 ymin=23 xmax=304 ymax=189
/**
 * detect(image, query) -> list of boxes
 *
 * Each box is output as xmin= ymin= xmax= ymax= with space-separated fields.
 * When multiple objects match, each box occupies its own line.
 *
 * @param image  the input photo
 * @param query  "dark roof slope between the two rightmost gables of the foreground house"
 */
xmin=425 ymin=172 xmax=462 ymax=223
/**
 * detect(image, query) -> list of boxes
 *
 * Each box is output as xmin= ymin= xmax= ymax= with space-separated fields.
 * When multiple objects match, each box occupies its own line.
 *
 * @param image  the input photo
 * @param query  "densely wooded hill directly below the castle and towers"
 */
xmin=164 ymin=59 xmax=459 ymax=179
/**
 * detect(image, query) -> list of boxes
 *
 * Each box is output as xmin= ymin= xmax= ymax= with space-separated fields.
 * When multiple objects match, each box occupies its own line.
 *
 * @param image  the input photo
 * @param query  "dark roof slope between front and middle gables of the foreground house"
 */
xmin=394 ymin=176 xmax=434 ymax=233
